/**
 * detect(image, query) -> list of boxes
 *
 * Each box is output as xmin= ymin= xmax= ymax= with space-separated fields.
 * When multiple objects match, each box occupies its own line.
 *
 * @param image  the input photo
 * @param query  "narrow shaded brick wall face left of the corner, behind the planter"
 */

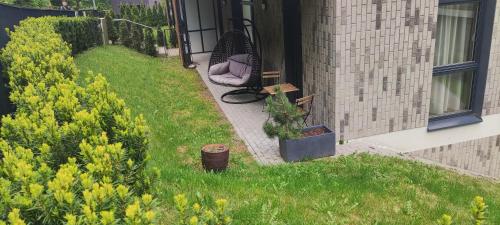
xmin=301 ymin=0 xmax=336 ymax=129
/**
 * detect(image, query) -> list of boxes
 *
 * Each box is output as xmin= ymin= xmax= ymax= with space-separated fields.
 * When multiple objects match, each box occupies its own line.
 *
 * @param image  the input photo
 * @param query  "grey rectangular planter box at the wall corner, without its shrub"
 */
xmin=280 ymin=125 xmax=335 ymax=162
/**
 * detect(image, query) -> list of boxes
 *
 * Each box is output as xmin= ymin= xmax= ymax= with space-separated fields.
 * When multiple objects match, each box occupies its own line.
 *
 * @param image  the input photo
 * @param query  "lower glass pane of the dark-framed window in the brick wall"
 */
xmin=430 ymin=71 xmax=474 ymax=117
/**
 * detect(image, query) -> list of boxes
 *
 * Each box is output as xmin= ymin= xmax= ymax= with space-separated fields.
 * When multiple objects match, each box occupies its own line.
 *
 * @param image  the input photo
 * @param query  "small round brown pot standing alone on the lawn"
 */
xmin=201 ymin=144 xmax=229 ymax=172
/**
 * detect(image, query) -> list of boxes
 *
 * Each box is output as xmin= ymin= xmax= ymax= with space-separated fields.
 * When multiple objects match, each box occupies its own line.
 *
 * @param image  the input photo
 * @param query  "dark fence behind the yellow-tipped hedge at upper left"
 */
xmin=0 ymin=3 xmax=75 ymax=115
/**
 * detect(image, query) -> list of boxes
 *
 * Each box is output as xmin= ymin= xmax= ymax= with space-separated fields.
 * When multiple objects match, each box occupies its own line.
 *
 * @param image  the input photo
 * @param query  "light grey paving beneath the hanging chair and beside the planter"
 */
xmin=193 ymin=54 xmax=397 ymax=165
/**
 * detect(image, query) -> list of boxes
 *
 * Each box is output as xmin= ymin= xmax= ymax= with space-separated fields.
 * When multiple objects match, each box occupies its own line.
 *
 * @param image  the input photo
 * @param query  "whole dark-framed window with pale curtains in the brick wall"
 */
xmin=428 ymin=0 xmax=494 ymax=130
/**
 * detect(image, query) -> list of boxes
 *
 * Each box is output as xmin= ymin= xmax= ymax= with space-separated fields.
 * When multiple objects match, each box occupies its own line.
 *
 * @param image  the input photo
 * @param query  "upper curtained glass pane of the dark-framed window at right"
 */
xmin=434 ymin=2 xmax=479 ymax=66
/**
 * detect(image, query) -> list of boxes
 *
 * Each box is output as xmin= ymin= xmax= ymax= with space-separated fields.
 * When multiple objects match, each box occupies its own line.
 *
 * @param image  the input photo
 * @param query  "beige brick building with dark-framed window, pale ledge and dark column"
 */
xmin=179 ymin=0 xmax=500 ymax=177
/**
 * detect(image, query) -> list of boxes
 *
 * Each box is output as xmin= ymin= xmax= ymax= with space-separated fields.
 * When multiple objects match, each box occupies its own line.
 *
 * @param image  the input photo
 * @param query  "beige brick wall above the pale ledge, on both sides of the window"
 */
xmin=302 ymin=0 xmax=500 ymax=139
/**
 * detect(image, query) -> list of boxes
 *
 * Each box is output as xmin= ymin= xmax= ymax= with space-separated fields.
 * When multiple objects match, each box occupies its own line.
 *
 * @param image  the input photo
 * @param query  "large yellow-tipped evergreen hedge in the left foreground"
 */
xmin=0 ymin=17 xmax=155 ymax=224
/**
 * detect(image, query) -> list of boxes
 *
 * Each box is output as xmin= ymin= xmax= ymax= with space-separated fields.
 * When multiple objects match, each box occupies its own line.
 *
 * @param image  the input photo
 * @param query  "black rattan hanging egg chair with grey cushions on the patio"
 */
xmin=208 ymin=20 xmax=266 ymax=104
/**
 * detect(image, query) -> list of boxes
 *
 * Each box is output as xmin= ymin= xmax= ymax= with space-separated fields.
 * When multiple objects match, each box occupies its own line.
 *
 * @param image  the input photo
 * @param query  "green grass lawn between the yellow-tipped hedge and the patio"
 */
xmin=77 ymin=47 xmax=500 ymax=225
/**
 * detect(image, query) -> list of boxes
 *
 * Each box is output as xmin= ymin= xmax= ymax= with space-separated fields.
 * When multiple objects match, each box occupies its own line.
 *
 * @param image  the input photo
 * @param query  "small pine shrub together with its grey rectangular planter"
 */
xmin=264 ymin=90 xmax=335 ymax=162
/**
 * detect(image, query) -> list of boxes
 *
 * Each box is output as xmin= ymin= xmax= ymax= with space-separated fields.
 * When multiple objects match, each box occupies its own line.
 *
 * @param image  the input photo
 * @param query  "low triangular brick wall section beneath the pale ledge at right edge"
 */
xmin=409 ymin=136 xmax=500 ymax=178
